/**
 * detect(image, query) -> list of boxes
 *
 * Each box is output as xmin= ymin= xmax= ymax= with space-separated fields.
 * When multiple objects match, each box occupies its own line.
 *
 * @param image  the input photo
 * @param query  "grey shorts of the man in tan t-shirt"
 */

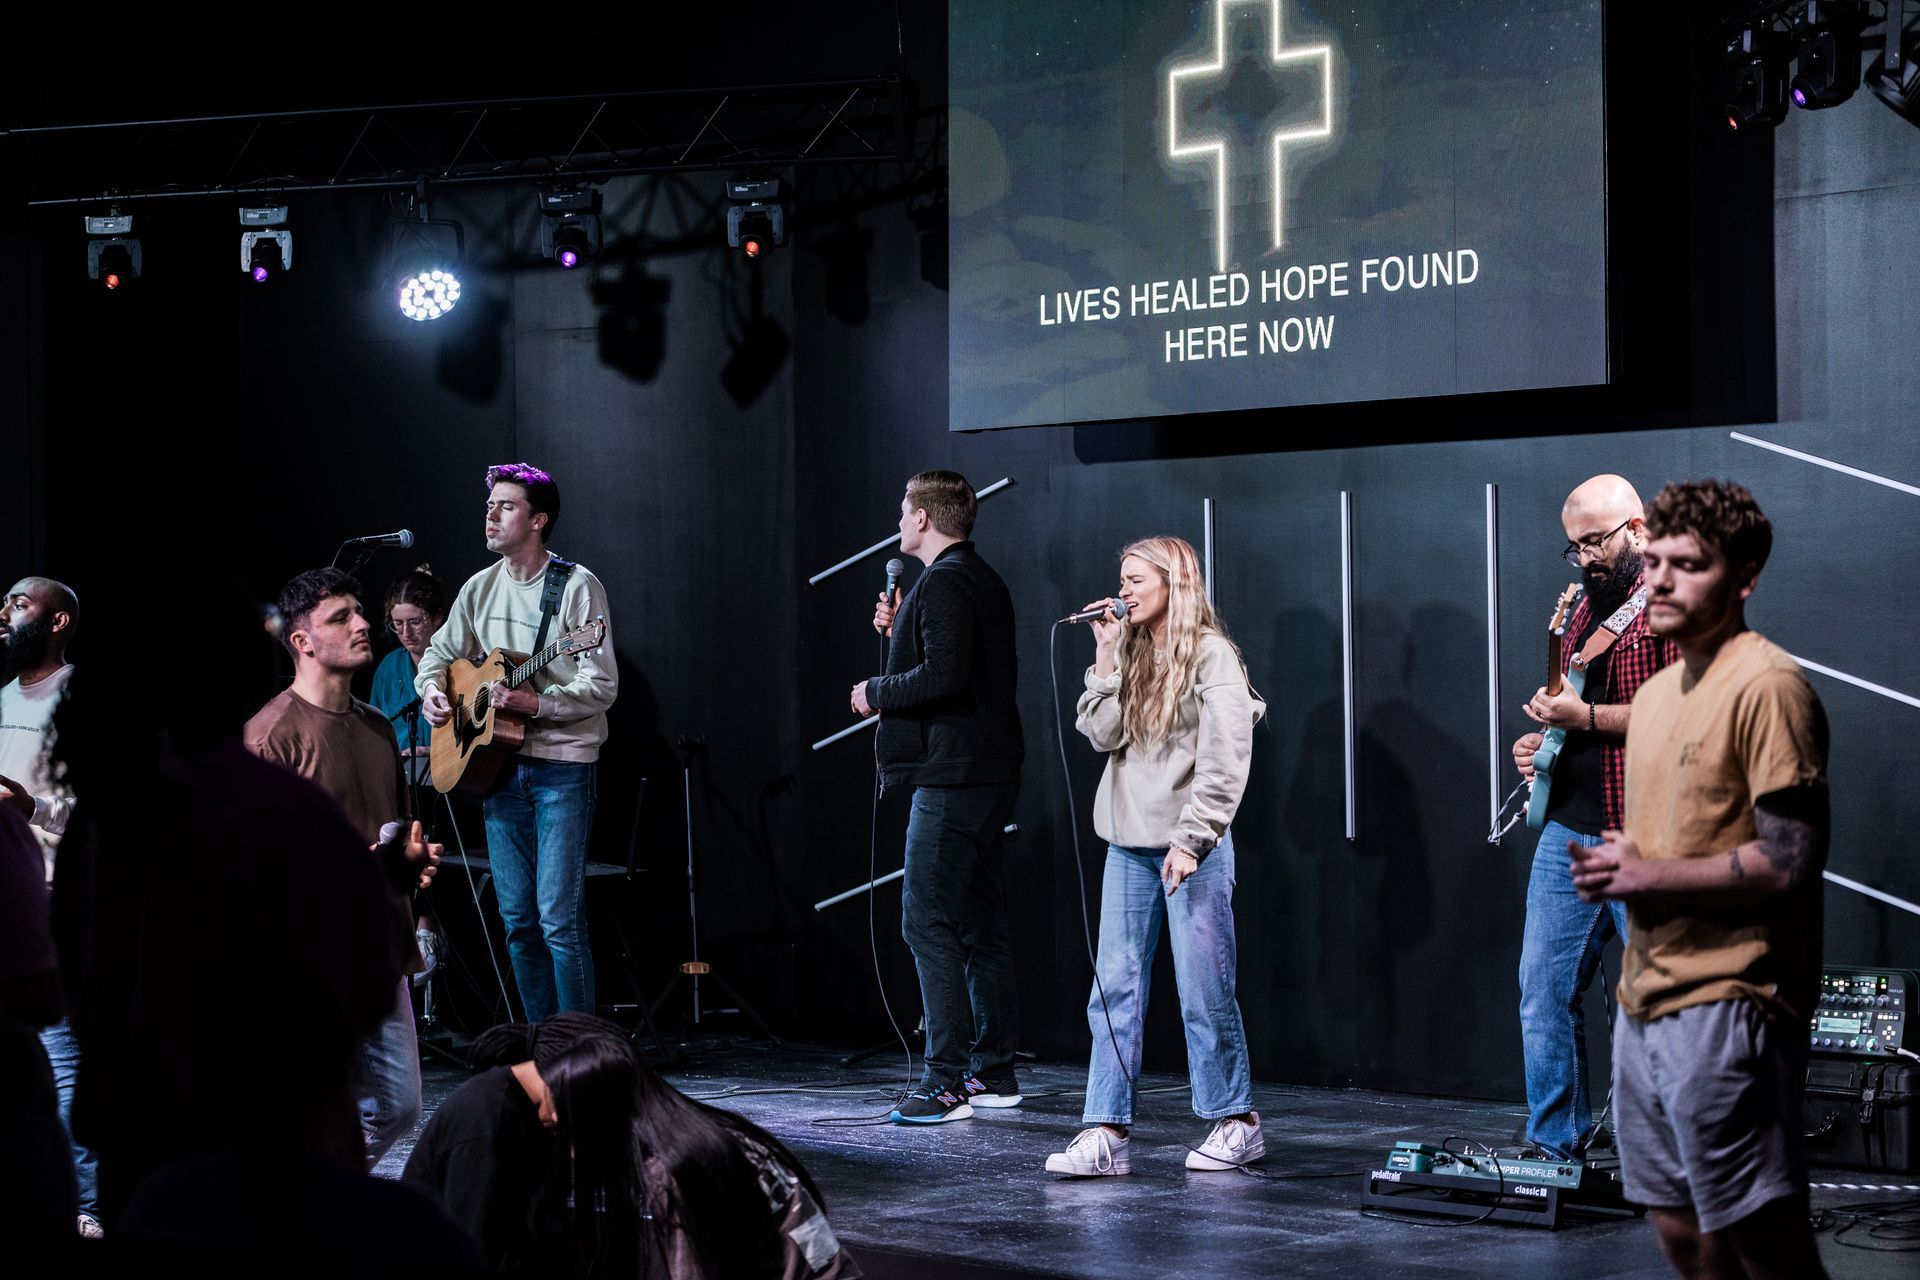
xmin=1613 ymin=1000 xmax=1807 ymax=1232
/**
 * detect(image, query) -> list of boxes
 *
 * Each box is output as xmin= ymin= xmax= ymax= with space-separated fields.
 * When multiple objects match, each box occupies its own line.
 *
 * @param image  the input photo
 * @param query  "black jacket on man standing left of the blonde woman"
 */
xmin=866 ymin=541 xmax=1025 ymax=787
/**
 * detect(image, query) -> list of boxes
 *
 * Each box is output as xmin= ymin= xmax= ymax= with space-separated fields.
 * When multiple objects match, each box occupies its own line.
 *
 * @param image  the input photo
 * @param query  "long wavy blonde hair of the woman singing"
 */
xmin=1114 ymin=537 xmax=1246 ymax=747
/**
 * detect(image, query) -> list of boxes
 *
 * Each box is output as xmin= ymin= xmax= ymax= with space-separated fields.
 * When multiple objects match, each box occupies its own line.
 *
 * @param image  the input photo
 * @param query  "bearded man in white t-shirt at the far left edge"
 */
xmin=0 ymin=578 xmax=100 ymax=1236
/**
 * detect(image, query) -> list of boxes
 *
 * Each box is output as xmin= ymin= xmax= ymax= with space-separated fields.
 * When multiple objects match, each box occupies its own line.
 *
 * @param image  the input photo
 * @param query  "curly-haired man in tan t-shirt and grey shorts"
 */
xmin=1571 ymin=480 xmax=1828 ymax=1276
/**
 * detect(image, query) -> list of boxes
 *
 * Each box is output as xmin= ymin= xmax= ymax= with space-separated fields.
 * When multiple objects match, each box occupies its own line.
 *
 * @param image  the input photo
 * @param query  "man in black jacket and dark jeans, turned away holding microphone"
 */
xmin=852 ymin=470 xmax=1023 ymax=1125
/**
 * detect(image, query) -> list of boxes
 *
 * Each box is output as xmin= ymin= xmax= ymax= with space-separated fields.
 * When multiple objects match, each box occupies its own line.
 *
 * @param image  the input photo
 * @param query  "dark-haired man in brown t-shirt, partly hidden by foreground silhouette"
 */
xmin=244 ymin=568 xmax=440 ymax=1167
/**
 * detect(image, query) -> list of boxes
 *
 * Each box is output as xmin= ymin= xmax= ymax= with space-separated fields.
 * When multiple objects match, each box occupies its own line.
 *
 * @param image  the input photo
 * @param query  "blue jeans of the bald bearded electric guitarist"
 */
xmin=1521 ymin=821 xmax=1626 ymax=1157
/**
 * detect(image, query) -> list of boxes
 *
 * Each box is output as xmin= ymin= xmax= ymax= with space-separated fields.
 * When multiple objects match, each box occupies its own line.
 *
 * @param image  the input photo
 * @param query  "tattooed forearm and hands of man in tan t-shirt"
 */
xmin=1571 ymin=787 xmax=1828 ymax=902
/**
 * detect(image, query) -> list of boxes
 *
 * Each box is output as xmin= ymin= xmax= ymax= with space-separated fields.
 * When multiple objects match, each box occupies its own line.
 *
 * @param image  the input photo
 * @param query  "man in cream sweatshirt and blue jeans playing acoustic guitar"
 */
xmin=413 ymin=462 xmax=620 ymax=1023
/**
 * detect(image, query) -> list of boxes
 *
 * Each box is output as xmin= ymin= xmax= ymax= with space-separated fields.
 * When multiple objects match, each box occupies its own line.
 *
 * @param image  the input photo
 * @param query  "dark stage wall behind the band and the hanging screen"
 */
xmin=8 ymin=6 xmax=1920 ymax=1098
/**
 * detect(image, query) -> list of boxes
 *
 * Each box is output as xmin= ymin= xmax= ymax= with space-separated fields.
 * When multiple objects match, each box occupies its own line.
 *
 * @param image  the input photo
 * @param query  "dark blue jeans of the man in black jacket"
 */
xmin=900 ymin=783 xmax=1020 ymax=1088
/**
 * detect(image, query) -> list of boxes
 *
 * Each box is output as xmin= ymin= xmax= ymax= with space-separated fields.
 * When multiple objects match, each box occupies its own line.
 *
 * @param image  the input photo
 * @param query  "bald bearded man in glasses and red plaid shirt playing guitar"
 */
xmin=1513 ymin=476 xmax=1678 ymax=1159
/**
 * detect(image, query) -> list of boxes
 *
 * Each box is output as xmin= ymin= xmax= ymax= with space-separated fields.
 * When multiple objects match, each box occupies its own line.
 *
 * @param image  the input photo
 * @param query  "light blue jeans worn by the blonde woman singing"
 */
xmin=1081 ymin=831 xmax=1254 ymax=1125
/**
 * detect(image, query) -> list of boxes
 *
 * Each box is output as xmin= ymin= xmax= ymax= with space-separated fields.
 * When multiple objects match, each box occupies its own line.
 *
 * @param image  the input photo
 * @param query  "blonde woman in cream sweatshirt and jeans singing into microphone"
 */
xmin=1046 ymin=537 xmax=1267 ymax=1176
